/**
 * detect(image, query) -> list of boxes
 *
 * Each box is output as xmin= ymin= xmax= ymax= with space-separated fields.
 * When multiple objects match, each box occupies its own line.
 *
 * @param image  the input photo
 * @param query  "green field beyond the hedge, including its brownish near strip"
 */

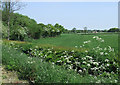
xmin=3 ymin=33 xmax=118 ymax=51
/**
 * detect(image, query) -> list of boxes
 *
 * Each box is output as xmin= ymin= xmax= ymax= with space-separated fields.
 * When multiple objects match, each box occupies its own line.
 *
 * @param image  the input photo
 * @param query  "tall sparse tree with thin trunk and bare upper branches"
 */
xmin=2 ymin=0 xmax=23 ymax=40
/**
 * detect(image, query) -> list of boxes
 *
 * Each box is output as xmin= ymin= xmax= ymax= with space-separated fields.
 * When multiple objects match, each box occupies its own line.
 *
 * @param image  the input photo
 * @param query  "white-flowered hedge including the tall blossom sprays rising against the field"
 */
xmin=3 ymin=36 xmax=119 ymax=82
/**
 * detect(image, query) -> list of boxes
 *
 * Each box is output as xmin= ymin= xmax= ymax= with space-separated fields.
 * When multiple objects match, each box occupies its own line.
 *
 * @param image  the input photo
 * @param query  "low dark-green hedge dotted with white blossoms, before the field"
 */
xmin=21 ymin=38 xmax=118 ymax=76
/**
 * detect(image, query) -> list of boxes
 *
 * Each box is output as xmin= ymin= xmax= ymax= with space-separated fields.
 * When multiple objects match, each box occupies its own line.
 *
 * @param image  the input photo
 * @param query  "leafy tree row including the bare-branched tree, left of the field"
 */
xmin=0 ymin=0 xmax=64 ymax=41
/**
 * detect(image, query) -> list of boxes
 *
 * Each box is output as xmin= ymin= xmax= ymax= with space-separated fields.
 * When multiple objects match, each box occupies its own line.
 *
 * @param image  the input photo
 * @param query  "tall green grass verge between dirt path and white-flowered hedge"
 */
xmin=2 ymin=45 xmax=119 ymax=85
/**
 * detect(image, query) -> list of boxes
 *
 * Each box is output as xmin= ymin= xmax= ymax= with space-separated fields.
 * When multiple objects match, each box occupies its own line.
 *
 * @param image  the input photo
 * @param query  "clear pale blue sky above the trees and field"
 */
xmin=18 ymin=2 xmax=118 ymax=29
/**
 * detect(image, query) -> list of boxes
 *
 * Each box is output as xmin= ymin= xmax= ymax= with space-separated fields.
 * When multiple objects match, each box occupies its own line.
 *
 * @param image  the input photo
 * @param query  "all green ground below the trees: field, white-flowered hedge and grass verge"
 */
xmin=2 ymin=33 xmax=119 ymax=83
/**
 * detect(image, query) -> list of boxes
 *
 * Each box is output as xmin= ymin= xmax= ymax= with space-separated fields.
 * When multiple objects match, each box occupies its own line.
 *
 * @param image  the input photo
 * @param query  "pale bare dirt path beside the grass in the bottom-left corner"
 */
xmin=0 ymin=66 xmax=29 ymax=85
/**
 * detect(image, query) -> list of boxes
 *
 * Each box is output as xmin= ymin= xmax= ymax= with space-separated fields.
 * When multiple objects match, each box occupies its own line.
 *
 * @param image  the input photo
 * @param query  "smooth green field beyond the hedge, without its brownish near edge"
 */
xmin=32 ymin=34 xmax=118 ymax=50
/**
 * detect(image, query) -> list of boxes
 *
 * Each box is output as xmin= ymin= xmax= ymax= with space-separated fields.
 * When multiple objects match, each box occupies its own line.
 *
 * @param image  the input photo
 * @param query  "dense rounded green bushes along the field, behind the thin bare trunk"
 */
xmin=2 ymin=11 xmax=64 ymax=41
